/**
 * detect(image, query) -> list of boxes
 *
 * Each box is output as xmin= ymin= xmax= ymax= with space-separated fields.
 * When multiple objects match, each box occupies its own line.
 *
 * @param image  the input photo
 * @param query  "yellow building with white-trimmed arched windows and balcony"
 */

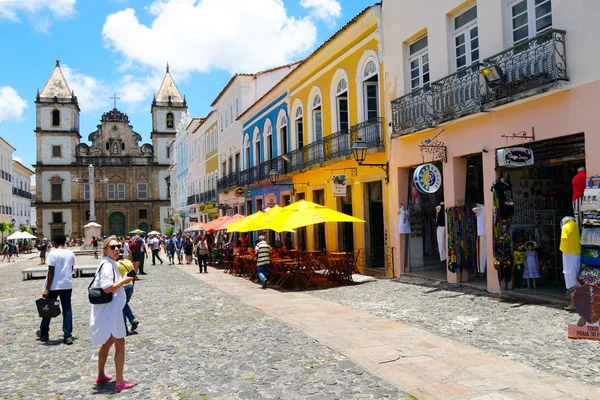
xmin=288 ymin=5 xmax=391 ymax=274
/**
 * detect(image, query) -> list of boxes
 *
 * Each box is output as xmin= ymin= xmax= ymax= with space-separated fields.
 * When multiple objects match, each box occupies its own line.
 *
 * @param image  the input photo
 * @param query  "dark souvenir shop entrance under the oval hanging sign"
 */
xmin=494 ymin=134 xmax=585 ymax=297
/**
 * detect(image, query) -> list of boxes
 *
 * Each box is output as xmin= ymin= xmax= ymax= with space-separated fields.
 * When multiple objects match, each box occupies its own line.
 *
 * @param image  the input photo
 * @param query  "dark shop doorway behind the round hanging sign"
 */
xmin=403 ymin=163 xmax=446 ymax=280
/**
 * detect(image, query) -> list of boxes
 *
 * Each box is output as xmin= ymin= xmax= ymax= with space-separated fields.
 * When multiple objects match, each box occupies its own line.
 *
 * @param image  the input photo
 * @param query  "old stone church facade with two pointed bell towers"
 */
xmin=35 ymin=60 xmax=187 ymax=238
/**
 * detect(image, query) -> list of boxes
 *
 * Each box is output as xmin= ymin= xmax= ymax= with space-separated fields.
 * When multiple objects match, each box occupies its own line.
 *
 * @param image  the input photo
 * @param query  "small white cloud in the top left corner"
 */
xmin=0 ymin=0 xmax=77 ymax=32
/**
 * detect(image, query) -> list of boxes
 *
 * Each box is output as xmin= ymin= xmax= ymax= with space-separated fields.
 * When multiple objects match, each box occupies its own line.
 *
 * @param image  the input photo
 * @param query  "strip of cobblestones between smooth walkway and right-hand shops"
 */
xmin=310 ymin=278 xmax=600 ymax=386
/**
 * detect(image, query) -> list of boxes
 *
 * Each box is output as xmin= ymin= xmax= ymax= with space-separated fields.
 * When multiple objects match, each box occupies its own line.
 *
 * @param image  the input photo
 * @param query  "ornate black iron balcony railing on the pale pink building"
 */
xmin=392 ymin=29 xmax=568 ymax=137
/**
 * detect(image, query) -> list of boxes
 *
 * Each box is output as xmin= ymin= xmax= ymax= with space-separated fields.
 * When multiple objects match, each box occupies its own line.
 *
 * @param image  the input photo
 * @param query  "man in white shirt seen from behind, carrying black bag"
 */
xmin=36 ymin=233 xmax=75 ymax=344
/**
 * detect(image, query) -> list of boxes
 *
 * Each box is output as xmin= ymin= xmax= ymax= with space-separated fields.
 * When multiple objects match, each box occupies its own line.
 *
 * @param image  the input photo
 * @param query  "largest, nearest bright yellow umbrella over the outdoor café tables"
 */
xmin=261 ymin=200 xmax=365 ymax=232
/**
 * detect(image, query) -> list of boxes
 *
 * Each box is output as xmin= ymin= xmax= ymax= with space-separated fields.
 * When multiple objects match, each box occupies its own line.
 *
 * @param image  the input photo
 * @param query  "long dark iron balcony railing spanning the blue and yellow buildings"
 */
xmin=217 ymin=118 xmax=383 ymax=191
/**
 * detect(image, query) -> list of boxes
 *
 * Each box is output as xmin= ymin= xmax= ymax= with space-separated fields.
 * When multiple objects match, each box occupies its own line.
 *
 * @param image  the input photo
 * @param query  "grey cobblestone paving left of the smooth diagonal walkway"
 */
xmin=0 ymin=257 xmax=405 ymax=400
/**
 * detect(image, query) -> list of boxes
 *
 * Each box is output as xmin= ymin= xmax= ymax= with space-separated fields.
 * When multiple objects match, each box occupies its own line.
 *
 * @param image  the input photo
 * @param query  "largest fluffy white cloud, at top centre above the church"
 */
xmin=102 ymin=0 xmax=317 ymax=73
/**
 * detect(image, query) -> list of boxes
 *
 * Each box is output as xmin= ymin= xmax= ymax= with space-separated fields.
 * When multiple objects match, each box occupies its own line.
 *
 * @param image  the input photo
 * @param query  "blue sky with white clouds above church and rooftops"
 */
xmin=0 ymin=0 xmax=376 ymax=169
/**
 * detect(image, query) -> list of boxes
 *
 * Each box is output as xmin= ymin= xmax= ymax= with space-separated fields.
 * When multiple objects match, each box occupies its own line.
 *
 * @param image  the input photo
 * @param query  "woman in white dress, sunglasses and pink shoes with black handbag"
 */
xmin=90 ymin=236 xmax=135 ymax=391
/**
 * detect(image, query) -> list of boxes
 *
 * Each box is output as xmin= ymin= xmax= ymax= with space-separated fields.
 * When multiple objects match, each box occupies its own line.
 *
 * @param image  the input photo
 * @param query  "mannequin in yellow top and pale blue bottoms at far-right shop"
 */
xmin=560 ymin=217 xmax=581 ymax=311
